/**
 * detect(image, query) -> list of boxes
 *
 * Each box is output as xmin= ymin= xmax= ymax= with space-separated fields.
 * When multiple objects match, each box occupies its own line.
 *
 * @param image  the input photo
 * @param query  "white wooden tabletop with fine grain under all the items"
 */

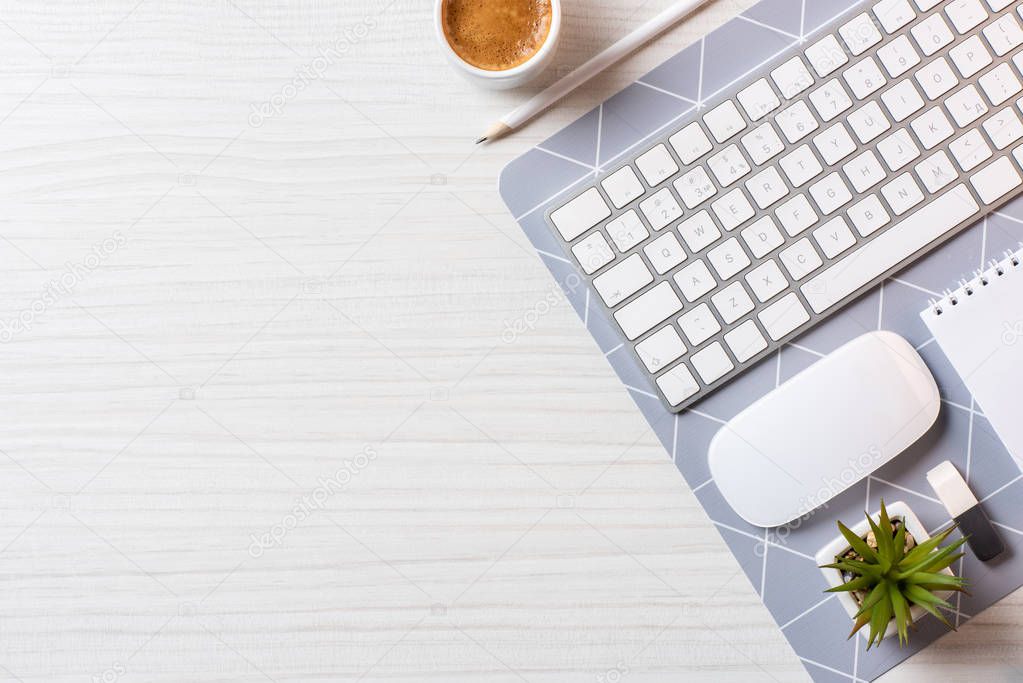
xmin=0 ymin=0 xmax=1023 ymax=683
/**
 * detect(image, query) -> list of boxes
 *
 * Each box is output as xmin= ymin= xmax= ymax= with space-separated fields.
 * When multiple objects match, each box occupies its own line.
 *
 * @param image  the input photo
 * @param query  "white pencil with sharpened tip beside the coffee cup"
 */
xmin=476 ymin=0 xmax=708 ymax=144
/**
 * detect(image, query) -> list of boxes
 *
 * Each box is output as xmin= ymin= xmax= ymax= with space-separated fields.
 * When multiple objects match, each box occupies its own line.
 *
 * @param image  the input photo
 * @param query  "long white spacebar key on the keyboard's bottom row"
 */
xmin=800 ymin=183 xmax=980 ymax=313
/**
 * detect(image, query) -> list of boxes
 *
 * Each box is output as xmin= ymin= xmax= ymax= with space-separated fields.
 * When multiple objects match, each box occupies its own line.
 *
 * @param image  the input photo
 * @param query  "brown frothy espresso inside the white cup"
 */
xmin=443 ymin=0 xmax=551 ymax=72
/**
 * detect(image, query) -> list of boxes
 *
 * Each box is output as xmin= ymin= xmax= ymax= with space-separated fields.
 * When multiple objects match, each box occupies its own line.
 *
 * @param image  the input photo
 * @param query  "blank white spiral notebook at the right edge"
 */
xmin=921 ymin=248 xmax=1023 ymax=465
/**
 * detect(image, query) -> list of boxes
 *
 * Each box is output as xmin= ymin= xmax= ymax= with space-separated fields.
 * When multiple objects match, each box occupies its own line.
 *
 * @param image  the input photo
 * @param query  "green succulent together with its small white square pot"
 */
xmin=816 ymin=501 xmax=966 ymax=649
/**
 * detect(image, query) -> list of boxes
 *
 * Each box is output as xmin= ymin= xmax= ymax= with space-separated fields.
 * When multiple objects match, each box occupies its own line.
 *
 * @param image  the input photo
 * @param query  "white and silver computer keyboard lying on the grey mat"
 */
xmin=547 ymin=0 xmax=1023 ymax=412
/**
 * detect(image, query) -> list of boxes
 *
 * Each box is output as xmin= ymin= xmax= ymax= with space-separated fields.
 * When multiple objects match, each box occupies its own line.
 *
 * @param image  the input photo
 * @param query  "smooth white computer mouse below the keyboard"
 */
xmin=708 ymin=331 xmax=941 ymax=527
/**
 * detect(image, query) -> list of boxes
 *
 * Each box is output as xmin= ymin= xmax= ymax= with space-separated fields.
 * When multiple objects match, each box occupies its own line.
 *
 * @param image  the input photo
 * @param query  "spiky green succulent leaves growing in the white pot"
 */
xmin=821 ymin=501 xmax=966 ymax=649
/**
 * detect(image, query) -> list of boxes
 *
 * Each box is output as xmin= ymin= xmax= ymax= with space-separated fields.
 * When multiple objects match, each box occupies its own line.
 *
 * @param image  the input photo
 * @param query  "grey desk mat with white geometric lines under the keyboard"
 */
xmin=500 ymin=0 xmax=1023 ymax=681
